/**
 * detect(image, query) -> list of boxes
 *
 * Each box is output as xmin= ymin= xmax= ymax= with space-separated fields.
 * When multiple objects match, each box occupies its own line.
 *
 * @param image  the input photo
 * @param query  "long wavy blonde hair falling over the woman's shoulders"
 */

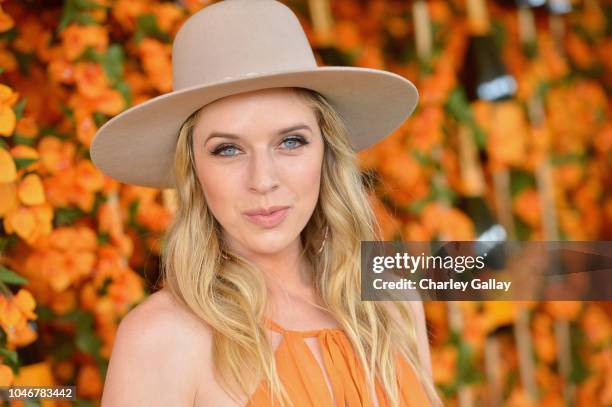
xmin=162 ymin=88 xmax=440 ymax=406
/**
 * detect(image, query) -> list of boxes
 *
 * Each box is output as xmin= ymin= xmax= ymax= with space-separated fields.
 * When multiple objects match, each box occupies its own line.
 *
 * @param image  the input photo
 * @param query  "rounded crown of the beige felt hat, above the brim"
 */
xmin=172 ymin=0 xmax=317 ymax=90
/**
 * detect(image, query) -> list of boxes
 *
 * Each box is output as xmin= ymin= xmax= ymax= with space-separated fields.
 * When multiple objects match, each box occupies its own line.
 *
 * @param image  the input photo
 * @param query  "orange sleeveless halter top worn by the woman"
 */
xmin=245 ymin=317 xmax=431 ymax=407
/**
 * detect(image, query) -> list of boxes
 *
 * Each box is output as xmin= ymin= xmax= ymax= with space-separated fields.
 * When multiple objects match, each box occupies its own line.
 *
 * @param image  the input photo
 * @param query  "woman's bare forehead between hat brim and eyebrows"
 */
xmin=194 ymin=88 xmax=316 ymax=135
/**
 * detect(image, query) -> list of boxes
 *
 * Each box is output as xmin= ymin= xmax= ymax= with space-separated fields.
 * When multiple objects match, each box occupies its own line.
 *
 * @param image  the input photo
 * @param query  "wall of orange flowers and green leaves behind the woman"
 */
xmin=0 ymin=0 xmax=612 ymax=406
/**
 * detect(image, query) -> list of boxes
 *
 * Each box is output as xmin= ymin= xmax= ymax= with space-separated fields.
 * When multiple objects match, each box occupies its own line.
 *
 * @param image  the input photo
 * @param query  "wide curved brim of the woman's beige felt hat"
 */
xmin=90 ymin=66 xmax=419 ymax=189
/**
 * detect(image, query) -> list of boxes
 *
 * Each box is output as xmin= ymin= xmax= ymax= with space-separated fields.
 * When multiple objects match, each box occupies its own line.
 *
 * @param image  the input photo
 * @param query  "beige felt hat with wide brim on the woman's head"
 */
xmin=90 ymin=0 xmax=418 ymax=188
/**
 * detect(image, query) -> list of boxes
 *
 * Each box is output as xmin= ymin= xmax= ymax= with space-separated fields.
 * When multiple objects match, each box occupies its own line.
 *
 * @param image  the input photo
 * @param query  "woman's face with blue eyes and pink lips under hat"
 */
xmin=193 ymin=88 xmax=324 ymax=255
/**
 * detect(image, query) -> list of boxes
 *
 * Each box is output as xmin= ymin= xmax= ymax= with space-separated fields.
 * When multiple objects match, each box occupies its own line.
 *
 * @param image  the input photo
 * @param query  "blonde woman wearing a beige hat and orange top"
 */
xmin=92 ymin=0 xmax=439 ymax=407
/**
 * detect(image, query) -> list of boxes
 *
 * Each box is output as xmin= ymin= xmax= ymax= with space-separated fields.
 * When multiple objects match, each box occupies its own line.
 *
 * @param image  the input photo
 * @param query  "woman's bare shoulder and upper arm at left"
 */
xmin=102 ymin=290 xmax=211 ymax=407
